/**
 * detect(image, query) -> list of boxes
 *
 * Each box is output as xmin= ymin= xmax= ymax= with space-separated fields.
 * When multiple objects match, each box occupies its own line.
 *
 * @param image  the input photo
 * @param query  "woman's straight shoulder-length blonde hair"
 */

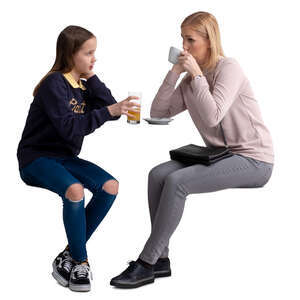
xmin=181 ymin=11 xmax=225 ymax=71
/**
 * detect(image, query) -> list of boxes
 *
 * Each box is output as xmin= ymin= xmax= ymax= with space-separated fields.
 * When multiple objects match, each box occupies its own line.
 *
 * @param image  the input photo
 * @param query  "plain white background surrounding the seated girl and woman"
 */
xmin=0 ymin=0 xmax=300 ymax=300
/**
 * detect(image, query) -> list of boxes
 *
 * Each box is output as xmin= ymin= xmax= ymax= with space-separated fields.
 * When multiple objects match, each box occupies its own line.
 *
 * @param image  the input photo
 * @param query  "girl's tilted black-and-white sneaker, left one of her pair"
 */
xmin=52 ymin=249 xmax=75 ymax=286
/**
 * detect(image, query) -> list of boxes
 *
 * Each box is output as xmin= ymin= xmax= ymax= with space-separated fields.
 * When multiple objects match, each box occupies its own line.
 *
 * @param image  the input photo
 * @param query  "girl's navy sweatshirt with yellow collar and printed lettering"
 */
xmin=17 ymin=72 xmax=120 ymax=169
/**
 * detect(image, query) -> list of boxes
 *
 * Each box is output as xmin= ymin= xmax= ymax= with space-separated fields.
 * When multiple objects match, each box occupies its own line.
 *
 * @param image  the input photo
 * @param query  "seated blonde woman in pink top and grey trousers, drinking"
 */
xmin=111 ymin=12 xmax=274 ymax=288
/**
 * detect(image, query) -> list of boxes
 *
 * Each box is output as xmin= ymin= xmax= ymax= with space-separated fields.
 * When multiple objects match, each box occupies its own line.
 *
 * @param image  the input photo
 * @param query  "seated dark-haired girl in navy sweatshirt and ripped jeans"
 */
xmin=17 ymin=26 xmax=138 ymax=291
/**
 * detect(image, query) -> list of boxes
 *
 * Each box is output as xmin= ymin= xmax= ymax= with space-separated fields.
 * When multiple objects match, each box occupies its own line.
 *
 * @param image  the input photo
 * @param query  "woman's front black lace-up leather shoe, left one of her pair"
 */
xmin=110 ymin=261 xmax=154 ymax=289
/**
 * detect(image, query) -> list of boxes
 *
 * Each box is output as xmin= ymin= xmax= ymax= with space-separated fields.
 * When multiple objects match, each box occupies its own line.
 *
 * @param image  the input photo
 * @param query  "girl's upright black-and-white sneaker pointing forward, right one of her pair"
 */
xmin=69 ymin=262 xmax=93 ymax=292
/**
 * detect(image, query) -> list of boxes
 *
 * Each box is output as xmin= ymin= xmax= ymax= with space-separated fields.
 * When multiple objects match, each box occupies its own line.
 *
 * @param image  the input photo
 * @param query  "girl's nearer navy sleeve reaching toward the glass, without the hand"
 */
xmin=38 ymin=73 xmax=112 ymax=142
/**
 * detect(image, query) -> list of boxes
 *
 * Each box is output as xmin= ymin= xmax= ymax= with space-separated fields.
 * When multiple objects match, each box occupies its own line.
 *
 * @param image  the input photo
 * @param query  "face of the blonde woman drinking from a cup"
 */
xmin=181 ymin=26 xmax=210 ymax=65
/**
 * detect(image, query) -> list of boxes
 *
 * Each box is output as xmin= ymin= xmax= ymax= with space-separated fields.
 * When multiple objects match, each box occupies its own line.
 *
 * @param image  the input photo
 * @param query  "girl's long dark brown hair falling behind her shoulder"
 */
xmin=33 ymin=25 xmax=95 ymax=97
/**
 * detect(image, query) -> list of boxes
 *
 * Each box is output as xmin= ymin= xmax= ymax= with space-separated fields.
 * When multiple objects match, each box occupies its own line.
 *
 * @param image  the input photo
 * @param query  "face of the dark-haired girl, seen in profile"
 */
xmin=73 ymin=37 xmax=97 ymax=74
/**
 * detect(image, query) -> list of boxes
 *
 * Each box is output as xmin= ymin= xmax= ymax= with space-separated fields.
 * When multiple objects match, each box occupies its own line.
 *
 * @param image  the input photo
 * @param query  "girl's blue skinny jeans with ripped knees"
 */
xmin=20 ymin=157 xmax=116 ymax=262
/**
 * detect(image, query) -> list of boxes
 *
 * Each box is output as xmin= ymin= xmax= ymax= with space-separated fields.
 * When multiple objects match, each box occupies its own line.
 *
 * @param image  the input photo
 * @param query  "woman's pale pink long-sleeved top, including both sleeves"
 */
xmin=150 ymin=57 xmax=274 ymax=163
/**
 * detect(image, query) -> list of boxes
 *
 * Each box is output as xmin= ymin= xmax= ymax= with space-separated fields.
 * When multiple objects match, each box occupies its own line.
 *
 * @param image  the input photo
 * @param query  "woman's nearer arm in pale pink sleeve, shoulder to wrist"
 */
xmin=191 ymin=60 xmax=245 ymax=127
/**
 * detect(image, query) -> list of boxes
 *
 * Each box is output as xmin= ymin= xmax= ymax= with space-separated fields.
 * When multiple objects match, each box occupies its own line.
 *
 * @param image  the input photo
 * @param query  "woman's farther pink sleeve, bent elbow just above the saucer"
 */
xmin=150 ymin=71 xmax=186 ymax=118
